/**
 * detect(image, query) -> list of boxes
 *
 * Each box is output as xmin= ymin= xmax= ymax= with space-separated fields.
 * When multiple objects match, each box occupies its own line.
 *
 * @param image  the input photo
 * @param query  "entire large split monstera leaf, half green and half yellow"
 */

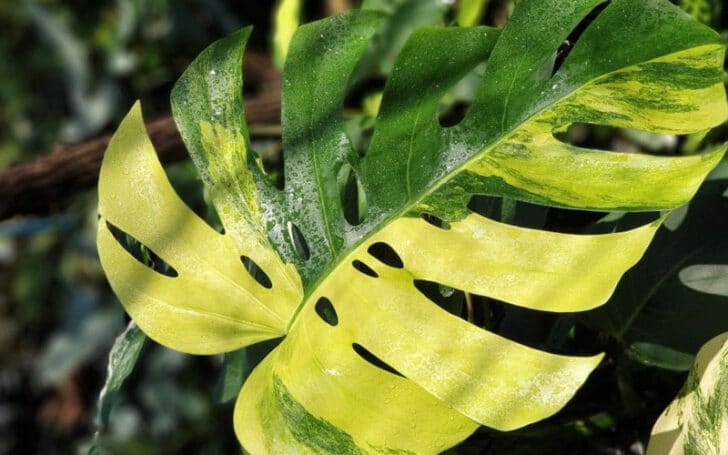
xmin=98 ymin=0 xmax=726 ymax=453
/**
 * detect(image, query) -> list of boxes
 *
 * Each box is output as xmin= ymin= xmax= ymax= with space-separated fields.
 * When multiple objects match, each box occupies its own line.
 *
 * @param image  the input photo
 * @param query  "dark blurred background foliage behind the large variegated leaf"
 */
xmin=0 ymin=0 xmax=728 ymax=454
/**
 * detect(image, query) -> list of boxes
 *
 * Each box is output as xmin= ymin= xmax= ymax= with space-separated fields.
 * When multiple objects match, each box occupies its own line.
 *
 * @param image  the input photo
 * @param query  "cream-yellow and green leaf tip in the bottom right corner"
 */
xmin=647 ymin=333 xmax=728 ymax=455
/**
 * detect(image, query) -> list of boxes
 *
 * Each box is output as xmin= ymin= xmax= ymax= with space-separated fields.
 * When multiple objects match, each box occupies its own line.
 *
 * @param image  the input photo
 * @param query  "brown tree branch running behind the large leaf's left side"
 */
xmin=0 ymin=51 xmax=281 ymax=220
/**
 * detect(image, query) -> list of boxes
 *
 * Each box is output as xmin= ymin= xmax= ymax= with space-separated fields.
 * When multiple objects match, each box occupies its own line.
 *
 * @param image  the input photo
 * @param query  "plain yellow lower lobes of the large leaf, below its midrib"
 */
xmin=235 ymin=215 xmax=632 ymax=453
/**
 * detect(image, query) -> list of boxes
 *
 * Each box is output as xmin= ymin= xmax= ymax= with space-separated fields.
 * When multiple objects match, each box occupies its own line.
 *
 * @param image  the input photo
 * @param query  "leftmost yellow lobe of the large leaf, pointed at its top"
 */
xmin=97 ymin=103 xmax=303 ymax=354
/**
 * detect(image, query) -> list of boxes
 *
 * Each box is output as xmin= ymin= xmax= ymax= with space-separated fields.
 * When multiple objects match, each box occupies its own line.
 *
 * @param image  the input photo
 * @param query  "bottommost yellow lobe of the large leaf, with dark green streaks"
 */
xmin=234 ymin=332 xmax=478 ymax=454
